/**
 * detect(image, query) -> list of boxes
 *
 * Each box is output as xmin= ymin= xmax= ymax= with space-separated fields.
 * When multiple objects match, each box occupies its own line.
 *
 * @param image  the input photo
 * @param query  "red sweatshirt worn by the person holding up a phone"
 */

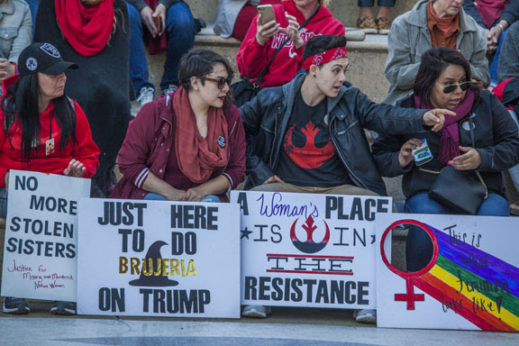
xmin=236 ymin=0 xmax=345 ymax=88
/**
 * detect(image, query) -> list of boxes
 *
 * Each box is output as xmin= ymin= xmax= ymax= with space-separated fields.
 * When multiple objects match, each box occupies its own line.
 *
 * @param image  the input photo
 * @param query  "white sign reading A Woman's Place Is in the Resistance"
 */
xmin=231 ymin=191 xmax=391 ymax=309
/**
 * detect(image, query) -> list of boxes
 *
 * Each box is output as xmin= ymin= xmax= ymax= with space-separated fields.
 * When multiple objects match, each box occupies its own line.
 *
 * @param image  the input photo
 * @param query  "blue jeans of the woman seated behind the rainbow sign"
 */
xmin=405 ymin=193 xmax=510 ymax=272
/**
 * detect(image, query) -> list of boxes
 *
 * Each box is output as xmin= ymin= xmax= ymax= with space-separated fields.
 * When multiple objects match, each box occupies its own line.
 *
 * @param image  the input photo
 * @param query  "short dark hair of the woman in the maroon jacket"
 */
xmin=178 ymin=49 xmax=234 ymax=90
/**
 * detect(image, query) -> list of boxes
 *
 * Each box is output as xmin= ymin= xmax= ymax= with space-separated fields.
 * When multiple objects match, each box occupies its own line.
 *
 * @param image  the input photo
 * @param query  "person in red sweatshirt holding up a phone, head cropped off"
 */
xmin=236 ymin=0 xmax=345 ymax=88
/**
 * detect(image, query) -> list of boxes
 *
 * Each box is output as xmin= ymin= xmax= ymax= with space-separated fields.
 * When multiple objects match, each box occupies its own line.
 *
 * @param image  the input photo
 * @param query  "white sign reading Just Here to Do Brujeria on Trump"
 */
xmin=78 ymin=199 xmax=240 ymax=318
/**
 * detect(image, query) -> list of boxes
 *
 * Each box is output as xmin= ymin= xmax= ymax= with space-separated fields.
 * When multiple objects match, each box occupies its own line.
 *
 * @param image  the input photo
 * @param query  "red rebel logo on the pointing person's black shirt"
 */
xmin=284 ymin=120 xmax=335 ymax=169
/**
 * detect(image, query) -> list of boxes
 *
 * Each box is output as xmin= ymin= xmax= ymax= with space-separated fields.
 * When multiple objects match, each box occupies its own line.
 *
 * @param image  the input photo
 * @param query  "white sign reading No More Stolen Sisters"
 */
xmin=2 ymin=170 xmax=90 ymax=301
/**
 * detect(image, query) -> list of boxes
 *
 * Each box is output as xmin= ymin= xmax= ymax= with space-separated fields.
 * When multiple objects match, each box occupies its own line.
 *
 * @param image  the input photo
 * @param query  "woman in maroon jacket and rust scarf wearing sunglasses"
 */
xmin=112 ymin=49 xmax=245 ymax=202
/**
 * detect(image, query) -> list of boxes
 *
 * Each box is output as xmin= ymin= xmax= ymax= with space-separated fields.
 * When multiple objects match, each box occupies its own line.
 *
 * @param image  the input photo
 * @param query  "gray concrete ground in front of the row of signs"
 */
xmin=0 ymin=309 xmax=519 ymax=346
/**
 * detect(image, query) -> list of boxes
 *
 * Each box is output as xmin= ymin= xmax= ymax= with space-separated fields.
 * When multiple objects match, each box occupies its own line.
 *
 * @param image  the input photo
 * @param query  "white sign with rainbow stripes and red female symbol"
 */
xmin=377 ymin=214 xmax=519 ymax=331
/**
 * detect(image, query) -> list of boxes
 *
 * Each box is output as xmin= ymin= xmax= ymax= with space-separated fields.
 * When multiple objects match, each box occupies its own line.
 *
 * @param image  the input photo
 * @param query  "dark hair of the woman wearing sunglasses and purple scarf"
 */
xmin=414 ymin=47 xmax=472 ymax=104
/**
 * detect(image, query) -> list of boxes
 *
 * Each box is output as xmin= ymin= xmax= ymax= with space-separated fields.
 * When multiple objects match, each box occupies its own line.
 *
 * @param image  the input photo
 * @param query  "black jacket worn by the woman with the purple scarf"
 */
xmin=373 ymin=90 xmax=519 ymax=198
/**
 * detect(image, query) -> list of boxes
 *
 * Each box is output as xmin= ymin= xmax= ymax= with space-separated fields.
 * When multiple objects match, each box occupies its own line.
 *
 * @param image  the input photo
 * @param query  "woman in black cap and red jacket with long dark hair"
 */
xmin=0 ymin=43 xmax=99 ymax=314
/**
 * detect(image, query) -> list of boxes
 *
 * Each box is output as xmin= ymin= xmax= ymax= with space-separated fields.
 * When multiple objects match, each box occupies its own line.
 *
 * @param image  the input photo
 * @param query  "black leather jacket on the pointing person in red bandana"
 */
xmin=240 ymin=74 xmax=425 ymax=195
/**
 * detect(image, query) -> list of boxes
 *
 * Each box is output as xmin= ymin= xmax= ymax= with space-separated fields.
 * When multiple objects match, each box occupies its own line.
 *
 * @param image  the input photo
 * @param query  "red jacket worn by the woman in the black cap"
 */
xmin=0 ymin=75 xmax=99 ymax=188
